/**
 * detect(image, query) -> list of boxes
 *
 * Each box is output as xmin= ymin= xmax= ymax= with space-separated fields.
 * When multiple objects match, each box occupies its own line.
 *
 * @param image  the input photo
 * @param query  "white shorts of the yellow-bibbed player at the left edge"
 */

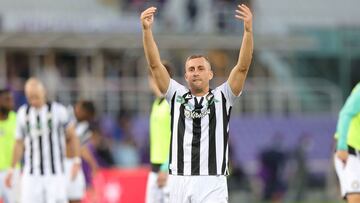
xmin=0 ymin=169 xmax=20 ymax=203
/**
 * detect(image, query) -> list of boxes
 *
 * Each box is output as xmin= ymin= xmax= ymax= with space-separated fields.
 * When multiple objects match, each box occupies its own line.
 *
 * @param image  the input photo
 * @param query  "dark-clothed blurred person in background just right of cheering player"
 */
xmin=259 ymin=133 xmax=286 ymax=202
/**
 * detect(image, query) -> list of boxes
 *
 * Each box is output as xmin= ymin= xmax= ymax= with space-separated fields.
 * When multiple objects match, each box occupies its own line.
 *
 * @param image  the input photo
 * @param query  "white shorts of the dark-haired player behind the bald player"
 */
xmin=65 ymin=158 xmax=86 ymax=200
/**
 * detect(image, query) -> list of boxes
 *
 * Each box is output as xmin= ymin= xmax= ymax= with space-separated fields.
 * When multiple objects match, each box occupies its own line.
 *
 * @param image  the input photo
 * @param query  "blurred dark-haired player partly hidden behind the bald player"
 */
xmin=65 ymin=100 xmax=98 ymax=203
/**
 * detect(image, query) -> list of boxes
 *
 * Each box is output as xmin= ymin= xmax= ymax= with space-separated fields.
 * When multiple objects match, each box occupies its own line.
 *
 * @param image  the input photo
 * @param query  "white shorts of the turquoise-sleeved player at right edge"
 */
xmin=334 ymin=154 xmax=360 ymax=198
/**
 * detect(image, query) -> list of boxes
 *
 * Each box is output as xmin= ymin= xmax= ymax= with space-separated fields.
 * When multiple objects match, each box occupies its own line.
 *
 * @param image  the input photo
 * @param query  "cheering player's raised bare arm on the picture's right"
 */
xmin=228 ymin=4 xmax=254 ymax=95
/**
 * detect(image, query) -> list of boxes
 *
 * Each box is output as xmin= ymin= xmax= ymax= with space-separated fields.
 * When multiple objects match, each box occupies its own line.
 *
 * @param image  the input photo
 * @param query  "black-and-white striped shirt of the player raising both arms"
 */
xmin=165 ymin=79 xmax=237 ymax=175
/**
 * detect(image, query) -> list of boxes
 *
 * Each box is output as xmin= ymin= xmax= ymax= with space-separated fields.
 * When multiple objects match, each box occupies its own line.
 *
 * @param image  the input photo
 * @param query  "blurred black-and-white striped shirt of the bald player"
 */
xmin=15 ymin=102 xmax=69 ymax=175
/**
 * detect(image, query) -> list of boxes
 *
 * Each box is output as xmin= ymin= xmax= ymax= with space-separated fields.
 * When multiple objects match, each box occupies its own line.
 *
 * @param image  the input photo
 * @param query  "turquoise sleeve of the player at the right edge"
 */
xmin=336 ymin=85 xmax=360 ymax=150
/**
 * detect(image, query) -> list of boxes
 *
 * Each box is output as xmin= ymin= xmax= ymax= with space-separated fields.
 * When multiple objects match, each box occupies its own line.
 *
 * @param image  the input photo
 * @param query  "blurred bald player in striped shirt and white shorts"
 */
xmin=6 ymin=78 xmax=81 ymax=203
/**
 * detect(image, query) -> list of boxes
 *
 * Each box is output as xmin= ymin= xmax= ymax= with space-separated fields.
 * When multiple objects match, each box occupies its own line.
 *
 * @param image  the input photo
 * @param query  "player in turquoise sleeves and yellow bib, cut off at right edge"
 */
xmin=335 ymin=83 xmax=360 ymax=203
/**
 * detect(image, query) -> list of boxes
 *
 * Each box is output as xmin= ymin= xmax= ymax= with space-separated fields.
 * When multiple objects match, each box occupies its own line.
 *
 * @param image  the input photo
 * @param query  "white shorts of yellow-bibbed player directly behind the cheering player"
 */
xmin=145 ymin=171 xmax=170 ymax=203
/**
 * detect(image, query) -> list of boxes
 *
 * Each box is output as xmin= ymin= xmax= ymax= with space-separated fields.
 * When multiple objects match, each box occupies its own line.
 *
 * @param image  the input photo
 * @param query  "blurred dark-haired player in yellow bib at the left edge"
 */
xmin=0 ymin=89 xmax=16 ymax=203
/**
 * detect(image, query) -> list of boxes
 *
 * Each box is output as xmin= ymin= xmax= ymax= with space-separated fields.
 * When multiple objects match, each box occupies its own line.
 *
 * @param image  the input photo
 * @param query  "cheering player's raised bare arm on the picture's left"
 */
xmin=140 ymin=7 xmax=170 ymax=94
